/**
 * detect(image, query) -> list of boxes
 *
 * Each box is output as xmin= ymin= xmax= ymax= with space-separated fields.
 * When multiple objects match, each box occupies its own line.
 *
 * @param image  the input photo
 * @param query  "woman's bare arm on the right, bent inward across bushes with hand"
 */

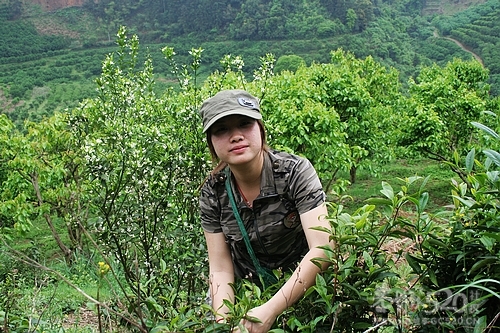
xmin=238 ymin=204 xmax=333 ymax=333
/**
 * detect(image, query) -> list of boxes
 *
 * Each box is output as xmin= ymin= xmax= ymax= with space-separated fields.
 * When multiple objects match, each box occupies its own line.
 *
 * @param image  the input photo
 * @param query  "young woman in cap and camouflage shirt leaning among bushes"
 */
xmin=200 ymin=90 xmax=329 ymax=333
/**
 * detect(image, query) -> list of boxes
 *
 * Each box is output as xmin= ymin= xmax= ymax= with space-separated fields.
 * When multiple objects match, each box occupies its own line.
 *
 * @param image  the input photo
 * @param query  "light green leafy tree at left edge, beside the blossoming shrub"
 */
xmin=0 ymin=114 xmax=85 ymax=261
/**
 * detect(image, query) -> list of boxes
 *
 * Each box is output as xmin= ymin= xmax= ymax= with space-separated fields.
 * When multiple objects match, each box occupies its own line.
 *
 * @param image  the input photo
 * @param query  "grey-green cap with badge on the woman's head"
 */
xmin=200 ymin=89 xmax=262 ymax=133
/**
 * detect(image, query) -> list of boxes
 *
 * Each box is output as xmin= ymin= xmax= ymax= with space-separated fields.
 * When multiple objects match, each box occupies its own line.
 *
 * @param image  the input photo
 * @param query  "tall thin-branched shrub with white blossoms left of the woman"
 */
xmin=70 ymin=28 xmax=208 ymax=329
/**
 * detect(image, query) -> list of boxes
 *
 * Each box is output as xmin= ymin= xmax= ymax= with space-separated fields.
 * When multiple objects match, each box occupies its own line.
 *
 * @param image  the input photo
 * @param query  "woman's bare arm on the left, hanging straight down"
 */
xmin=205 ymin=231 xmax=234 ymax=320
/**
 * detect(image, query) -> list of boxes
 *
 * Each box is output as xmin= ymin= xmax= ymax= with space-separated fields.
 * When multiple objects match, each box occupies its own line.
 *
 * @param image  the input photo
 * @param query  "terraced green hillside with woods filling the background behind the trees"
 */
xmin=0 ymin=0 xmax=500 ymax=128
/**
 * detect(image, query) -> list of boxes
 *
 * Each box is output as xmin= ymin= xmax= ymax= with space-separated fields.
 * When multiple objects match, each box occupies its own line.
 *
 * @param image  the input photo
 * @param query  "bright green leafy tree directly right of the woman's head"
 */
xmin=262 ymin=67 xmax=351 ymax=192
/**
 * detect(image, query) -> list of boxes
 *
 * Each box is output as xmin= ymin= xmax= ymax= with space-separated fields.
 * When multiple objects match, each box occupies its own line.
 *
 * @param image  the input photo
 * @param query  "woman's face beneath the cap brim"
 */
xmin=210 ymin=115 xmax=262 ymax=165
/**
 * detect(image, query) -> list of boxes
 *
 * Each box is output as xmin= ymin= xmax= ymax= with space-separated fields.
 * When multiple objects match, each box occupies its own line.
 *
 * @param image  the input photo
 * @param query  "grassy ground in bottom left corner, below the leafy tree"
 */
xmin=0 ymin=214 xmax=127 ymax=332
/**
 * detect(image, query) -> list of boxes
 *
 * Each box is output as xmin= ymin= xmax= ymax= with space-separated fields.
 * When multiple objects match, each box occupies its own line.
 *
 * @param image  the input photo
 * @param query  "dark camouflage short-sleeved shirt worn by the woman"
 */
xmin=200 ymin=151 xmax=325 ymax=278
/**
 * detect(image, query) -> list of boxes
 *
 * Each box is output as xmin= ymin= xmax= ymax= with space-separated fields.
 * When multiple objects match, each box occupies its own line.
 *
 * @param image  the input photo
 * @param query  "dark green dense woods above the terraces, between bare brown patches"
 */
xmin=80 ymin=0 xmax=362 ymax=42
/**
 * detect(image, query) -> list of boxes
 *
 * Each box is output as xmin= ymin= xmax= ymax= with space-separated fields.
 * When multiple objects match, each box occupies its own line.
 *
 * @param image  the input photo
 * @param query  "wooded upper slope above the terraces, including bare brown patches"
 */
xmin=14 ymin=0 xmax=486 ymax=42
